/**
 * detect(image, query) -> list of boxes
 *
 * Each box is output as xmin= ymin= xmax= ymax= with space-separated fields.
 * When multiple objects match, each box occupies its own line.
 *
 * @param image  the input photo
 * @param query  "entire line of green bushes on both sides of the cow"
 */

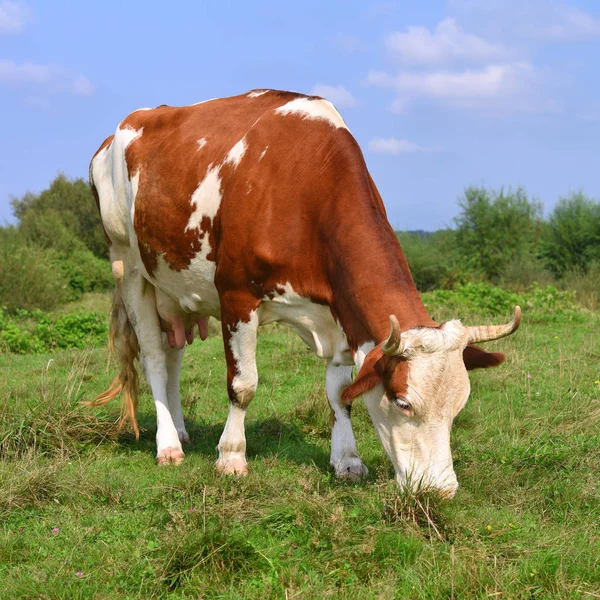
xmin=0 ymin=175 xmax=600 ymax=313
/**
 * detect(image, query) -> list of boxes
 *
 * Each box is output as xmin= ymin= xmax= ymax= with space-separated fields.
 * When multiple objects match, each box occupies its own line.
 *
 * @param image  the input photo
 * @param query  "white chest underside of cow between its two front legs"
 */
xmin=259 ymin=282 xmax=353 ymax=365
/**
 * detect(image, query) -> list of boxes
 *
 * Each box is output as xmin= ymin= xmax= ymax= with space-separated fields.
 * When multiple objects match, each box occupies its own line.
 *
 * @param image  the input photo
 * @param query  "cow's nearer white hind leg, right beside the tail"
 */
xmin=116 ymin=253 xmax=183 ymax=464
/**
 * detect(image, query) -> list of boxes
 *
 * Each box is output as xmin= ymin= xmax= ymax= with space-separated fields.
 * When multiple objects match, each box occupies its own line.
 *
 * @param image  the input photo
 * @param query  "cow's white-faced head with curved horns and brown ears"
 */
xmin=342 ymin=306 xmax=521 ymax=497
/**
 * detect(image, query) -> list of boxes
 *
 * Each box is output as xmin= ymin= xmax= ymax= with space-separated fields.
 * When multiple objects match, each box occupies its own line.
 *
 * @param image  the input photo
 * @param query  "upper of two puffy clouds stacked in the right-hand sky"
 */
xmin=385 ymin=18 xmax=507 ymax=64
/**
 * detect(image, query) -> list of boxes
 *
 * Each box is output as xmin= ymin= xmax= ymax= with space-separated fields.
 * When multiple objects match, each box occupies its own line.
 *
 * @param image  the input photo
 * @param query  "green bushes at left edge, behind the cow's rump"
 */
xmin=0 ymin=175 xmax=113 ymax=313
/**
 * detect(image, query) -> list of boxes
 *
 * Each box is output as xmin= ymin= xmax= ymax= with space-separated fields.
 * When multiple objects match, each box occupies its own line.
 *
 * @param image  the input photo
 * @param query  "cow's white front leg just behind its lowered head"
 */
xmin=325 ymin=361 xmax=369 ymax=479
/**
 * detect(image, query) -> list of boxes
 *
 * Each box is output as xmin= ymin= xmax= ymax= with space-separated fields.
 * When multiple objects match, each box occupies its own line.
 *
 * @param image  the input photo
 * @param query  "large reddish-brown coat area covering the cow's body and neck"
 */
xmin=96 ymin=90 xmax=435 ymax=350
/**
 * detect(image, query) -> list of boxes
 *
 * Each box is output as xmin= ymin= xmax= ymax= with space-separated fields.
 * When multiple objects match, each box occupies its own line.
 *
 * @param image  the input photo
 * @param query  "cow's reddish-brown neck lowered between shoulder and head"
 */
xmin=329 ymin=185 xmax=436 ymax=349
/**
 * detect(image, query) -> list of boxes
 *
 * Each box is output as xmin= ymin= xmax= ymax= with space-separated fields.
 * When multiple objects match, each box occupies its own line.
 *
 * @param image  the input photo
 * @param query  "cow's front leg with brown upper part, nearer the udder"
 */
xmin=216 ymin=294 xmax=258 ymax=475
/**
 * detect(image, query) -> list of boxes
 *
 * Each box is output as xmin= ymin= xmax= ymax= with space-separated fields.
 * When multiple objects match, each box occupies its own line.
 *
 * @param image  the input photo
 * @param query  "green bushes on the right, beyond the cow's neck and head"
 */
xmin=398 ymin=187 xmax=600 ymax=293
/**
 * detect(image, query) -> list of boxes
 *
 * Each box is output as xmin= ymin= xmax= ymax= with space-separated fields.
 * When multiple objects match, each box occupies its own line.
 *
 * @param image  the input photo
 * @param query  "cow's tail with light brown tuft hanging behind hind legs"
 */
xmin=85 ymin=288 xmax=140 ymax=439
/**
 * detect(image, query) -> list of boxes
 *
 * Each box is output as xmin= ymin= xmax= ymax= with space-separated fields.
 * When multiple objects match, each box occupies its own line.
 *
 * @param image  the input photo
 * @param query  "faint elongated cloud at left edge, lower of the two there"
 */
xmin=0 ymin=59 xmax=94 ymax=96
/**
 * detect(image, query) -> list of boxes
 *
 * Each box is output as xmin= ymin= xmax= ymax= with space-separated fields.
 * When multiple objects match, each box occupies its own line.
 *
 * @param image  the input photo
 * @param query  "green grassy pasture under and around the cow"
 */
xmin=0 ymin=294 xmax=600 ymax=600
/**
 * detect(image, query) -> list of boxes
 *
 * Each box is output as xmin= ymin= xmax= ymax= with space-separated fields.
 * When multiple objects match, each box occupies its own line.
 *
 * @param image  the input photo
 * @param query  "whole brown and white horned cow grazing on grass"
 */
xmin=90 ymin=90 xmax=520 ymax=496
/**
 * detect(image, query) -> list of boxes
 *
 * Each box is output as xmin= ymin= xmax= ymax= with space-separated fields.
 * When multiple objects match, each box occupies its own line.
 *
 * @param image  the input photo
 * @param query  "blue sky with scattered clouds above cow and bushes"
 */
xmin=0 ymin=0 xmax=600 ymax=231
